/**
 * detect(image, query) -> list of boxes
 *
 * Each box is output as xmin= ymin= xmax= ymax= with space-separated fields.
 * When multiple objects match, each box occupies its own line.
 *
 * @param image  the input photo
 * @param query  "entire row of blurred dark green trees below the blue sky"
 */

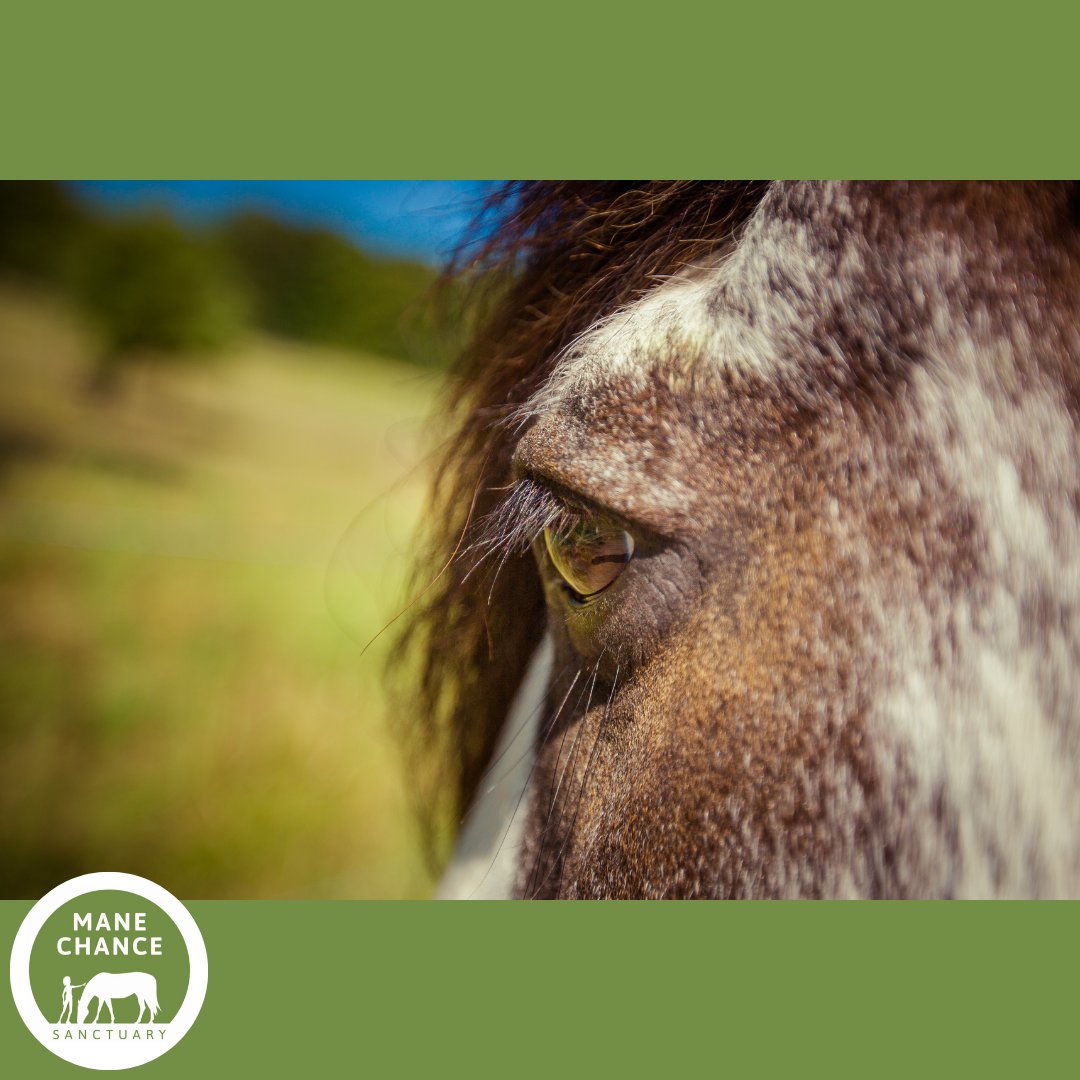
xmin=0 ymin=181 xmax=444 ymax=373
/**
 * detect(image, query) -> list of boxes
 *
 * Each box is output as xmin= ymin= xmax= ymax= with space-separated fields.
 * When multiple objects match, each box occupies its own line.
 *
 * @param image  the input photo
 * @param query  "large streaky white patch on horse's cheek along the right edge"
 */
xmin=870 ymin=338 xmax=1080 ymax=897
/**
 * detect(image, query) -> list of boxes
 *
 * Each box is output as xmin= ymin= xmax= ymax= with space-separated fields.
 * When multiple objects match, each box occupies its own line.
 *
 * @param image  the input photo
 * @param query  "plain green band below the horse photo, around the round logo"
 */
xmin=0 ymin=901 xmax=1080 ymax=1078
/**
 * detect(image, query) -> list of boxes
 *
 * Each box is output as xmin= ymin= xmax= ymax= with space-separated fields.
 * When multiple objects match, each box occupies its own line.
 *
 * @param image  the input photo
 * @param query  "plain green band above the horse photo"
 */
xmin=0 ymin=0 xmax=1080 ymax=178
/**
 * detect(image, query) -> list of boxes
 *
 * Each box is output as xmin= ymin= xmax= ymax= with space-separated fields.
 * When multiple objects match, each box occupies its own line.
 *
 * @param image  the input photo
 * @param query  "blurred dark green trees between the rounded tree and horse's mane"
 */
xmin=222 ymin=214 xmax=434 ymax=363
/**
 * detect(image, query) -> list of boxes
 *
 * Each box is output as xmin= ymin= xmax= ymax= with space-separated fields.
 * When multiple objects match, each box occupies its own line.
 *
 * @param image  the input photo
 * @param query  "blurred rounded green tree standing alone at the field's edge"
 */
xmin=79 ymin=215 xmax=246 ymax=377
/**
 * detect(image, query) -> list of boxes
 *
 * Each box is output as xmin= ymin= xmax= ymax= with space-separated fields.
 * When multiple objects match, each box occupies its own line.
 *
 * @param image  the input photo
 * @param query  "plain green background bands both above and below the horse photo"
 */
xmin=0 ymin=0 xmax=1080 ymax=1078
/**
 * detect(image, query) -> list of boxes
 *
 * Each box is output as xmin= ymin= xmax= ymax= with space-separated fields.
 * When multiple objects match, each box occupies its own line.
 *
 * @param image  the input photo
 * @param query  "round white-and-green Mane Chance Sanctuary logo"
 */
xmin=11 ymin=873 xmax=207 ymax=1069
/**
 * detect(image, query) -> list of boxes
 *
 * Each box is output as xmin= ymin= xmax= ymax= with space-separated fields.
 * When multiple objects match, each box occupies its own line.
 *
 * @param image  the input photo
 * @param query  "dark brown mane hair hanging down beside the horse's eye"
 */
xmin=395 ymin=180 xmax=765 ymax=861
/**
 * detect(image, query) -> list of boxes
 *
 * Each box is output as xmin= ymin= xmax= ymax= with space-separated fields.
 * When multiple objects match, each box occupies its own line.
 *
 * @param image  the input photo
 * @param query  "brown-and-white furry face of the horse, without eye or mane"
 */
xmin=406 ymin=185 xmax=1080 ymax=895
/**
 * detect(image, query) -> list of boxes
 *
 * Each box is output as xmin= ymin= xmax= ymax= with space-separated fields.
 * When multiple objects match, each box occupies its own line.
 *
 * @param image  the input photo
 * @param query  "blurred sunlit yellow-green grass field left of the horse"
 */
xmin=0 ymin=285 xmax=437 ymax=899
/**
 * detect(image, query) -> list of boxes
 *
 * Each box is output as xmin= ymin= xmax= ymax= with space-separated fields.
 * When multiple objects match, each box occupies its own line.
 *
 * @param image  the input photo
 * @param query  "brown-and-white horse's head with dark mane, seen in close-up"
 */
xmin=401 ymin=181 xmax=1080 ymax=899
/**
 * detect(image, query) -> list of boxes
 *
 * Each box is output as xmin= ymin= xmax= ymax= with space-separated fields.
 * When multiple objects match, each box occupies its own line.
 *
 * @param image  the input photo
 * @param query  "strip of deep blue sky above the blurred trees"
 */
xmin=75 ymin=180 xmax=492 ymax=262
